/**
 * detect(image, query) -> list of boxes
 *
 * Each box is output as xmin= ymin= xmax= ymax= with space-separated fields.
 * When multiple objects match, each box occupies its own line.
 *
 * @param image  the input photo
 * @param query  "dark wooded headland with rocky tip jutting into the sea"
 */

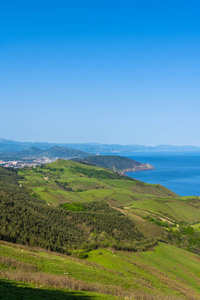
xmin=73 ymin=155 xmax=154 ymax=174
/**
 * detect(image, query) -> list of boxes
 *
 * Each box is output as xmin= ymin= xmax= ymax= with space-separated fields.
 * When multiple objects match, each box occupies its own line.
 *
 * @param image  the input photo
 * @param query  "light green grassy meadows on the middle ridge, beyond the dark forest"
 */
xmin=19 ymin=160 xmax=200 ymax=227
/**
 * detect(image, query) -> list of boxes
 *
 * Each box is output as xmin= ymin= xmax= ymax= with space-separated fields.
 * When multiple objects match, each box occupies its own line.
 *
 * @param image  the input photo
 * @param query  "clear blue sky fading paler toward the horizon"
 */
xmin=0 ymin=0 xmax=200 ymax=146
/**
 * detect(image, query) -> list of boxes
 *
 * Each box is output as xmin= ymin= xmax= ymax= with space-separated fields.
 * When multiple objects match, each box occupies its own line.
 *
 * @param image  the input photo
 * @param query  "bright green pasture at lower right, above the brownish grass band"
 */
xmin=87 ymin=244 xmax=200 ymax=299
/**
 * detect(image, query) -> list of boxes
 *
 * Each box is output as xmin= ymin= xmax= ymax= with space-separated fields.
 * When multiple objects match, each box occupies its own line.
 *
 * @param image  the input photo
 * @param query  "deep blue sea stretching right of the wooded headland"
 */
xmin=102 ymin=151 xmax=200 ymax=196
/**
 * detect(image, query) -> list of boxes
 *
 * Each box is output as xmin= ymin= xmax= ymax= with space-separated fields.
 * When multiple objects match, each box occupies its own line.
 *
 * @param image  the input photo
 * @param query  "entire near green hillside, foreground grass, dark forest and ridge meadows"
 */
xmin=0 ymin=160 xmax=200 ymax=300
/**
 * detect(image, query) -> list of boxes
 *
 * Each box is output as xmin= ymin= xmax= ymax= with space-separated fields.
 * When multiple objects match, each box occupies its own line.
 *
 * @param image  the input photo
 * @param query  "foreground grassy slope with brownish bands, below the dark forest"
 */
xmin=0 ymin=242 xmax=200 ymax=299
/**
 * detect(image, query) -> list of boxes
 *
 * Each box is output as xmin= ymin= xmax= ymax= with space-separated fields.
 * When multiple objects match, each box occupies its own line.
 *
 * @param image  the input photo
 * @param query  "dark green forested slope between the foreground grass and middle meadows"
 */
xmin=0 ymin=168 xmax=155 ymax=253
